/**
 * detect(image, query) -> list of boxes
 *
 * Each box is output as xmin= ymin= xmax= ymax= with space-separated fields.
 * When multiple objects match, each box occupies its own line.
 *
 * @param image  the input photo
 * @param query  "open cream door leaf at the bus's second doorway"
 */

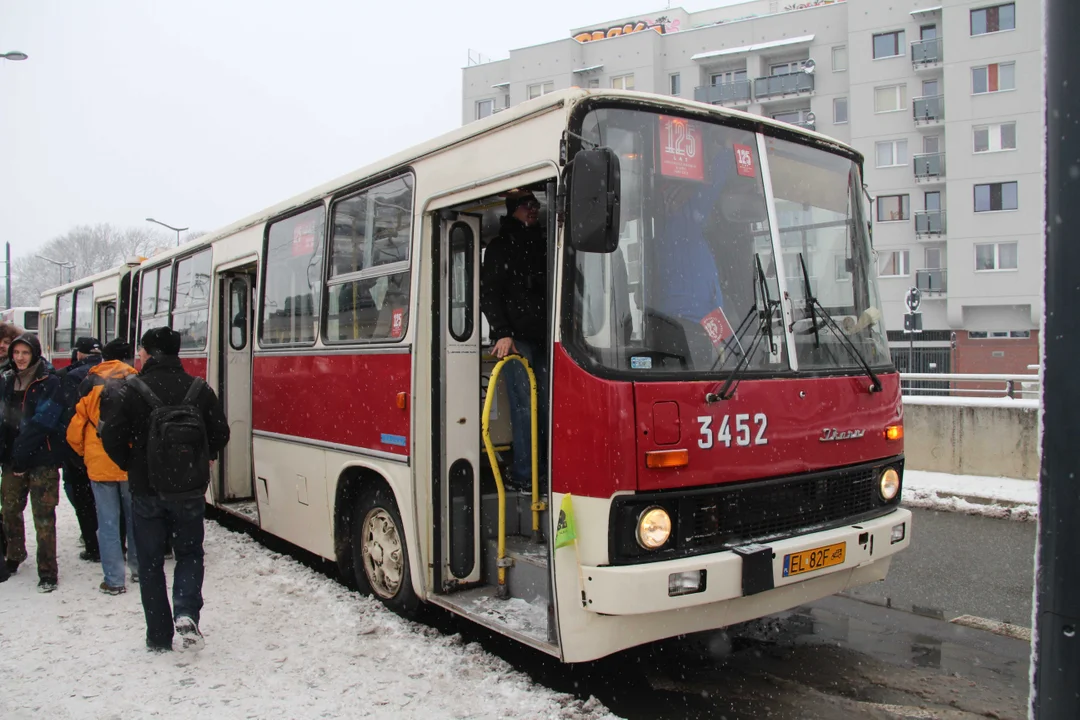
xmin=214 ymin=266 xmax=257 ymax=511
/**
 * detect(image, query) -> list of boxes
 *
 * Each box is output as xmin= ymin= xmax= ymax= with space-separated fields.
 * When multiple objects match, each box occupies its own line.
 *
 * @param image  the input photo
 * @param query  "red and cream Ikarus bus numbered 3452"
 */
xmin=42 ymin=89 xmax=912 ymax=662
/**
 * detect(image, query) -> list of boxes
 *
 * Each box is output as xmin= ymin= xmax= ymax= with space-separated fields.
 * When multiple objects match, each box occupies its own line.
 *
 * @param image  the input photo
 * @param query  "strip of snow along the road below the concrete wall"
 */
xmin=904 ymin=470 xmax=1039 ymax=520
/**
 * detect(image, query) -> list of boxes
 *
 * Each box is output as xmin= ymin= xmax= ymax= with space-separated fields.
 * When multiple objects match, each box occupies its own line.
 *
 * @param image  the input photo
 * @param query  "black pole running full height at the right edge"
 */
xmin=1031 ymin=0 xmax=1080 ymax=720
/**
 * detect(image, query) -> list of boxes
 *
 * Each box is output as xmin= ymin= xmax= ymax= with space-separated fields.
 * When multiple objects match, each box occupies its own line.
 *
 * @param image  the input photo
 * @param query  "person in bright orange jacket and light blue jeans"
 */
xmin=67 ymin=339 xmax=138 ymax=595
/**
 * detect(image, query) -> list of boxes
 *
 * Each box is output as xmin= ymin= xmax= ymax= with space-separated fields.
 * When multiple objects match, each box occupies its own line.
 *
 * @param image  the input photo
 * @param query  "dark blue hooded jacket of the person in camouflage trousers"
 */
xmin=0 ymin=335 xmax=66 ymax=473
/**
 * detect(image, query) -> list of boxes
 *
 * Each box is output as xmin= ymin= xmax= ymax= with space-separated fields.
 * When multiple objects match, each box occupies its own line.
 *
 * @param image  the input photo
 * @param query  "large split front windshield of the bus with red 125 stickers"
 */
xmin=565 ymin=108 xmax=890 ymax=377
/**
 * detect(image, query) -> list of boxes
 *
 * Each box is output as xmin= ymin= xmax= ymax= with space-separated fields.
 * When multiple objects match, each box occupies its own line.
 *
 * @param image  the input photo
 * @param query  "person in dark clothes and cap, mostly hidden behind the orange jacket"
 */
xmin=56 ymin=337 xmax=102 ymax=562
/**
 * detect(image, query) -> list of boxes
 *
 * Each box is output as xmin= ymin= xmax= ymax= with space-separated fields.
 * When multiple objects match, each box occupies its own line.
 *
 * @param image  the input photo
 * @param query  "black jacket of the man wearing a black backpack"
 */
xmin=98 ymin=355 xmax=229 ymax=495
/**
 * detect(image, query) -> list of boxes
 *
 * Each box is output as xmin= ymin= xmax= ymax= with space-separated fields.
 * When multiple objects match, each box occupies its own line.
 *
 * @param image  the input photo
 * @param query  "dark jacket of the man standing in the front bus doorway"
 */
xmin=480 ymin=217 xmax=548 ymax=342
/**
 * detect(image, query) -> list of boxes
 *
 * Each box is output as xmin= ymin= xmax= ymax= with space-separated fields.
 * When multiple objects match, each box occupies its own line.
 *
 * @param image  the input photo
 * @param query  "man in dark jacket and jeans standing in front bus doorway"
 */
xmin=480 ymin=191 xmax=548 ymax=491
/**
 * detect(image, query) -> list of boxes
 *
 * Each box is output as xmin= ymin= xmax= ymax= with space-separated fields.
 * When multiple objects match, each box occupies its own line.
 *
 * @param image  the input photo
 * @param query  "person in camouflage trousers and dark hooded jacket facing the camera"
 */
xmin=0 ymin=334 xmax=64 ymax=593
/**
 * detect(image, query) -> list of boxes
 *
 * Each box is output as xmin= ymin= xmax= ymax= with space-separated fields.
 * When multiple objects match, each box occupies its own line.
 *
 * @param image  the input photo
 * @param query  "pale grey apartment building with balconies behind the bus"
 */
xmin=462 ymin=0 xmax=1044 ymax=372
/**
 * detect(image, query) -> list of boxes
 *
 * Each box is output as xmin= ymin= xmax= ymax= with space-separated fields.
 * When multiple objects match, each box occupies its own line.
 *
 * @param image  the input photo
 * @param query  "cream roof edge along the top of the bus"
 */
xmin=135 ymin=87 xmax=862 ymax=266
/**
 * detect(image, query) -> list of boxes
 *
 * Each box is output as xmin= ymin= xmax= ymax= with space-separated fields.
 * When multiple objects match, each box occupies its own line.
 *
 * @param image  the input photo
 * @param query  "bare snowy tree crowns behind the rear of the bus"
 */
xmin=11 ymin=222 xmax=168 ymax=305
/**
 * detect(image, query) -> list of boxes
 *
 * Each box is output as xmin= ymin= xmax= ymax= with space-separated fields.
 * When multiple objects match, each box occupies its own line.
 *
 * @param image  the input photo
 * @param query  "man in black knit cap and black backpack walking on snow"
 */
xmin=99 ymin=327 xmax=229 ymax=652
